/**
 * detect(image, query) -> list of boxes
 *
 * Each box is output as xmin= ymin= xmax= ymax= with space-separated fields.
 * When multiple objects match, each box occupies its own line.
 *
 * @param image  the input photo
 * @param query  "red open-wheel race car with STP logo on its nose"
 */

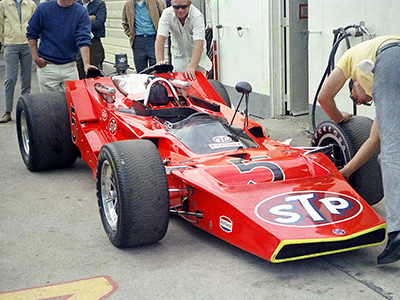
xmin=17 ymin=61 xmax=386 ymax=263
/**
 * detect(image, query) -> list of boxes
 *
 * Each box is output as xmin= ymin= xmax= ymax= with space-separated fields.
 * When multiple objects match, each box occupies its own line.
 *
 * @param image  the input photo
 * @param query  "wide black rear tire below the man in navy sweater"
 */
xmin=16 ymin=92 xmax=79 ymax=172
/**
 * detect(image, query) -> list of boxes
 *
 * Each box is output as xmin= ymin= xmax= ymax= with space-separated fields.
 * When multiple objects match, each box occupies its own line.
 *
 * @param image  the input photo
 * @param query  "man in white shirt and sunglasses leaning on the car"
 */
xmin=155 ymin=0 xmax=211 ymax=79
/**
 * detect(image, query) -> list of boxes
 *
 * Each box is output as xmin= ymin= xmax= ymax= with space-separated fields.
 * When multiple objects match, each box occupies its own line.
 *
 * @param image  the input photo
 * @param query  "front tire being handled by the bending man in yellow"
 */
xmin=311 ymin=116 xmax=383 ymax=205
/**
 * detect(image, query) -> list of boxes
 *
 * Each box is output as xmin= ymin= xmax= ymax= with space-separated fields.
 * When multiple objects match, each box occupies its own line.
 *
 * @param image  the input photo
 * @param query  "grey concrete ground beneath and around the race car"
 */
xmin=0 ymin=50 xmax=400 ymax=300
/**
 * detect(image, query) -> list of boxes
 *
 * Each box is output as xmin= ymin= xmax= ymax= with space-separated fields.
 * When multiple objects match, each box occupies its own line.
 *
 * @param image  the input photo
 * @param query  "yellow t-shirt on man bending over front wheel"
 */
xmin=336 ymin=35 xmax=400 ymax=96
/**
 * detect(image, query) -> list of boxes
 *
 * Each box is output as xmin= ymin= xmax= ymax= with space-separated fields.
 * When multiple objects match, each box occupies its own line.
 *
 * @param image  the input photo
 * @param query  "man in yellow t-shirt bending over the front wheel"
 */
xmin=318 ymin=36 xmax=400 ymax=264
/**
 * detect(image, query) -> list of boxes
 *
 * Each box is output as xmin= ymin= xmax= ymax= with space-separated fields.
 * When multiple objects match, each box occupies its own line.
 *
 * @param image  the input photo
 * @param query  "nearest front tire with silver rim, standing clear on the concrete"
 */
xmin=96 ymin=140 xmax=169 ymax=248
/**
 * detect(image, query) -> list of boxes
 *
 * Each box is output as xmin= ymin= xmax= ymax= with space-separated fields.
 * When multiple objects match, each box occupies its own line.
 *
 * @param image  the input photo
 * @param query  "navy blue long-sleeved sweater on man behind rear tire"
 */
xmin=26 ymin=0 xmax=91 ymax=64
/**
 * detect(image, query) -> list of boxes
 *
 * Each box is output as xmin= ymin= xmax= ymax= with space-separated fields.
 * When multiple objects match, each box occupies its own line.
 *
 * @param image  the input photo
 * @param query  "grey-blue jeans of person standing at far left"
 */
xmin=4 ymin=44 xmax=32 ymax=112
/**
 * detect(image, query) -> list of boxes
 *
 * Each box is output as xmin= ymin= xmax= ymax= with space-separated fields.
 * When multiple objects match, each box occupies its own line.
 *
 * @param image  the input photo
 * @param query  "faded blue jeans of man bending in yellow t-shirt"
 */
xmin=372 ymin=47 xmax=400 ymax=232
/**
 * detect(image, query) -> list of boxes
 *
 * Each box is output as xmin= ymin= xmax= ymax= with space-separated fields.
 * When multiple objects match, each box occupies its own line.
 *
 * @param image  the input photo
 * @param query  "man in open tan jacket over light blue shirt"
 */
xmin=122 ymin=0 xmax=165 ymax=73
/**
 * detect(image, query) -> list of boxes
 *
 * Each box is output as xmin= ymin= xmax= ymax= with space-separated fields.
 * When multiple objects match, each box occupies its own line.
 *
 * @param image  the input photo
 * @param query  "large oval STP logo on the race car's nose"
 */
xmin=255 ymin=191 xmax=363 ymax=227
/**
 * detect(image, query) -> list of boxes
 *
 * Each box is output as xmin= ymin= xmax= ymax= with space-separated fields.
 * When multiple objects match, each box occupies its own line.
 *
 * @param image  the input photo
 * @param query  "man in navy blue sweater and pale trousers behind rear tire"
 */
xmin=26 ymin=0 xmax=96 ymax=92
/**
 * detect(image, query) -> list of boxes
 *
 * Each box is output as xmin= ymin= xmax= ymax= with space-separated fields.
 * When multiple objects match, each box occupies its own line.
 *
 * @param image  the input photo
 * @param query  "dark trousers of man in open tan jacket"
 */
xmin=132 ymin=35 xmax=156 ymax=73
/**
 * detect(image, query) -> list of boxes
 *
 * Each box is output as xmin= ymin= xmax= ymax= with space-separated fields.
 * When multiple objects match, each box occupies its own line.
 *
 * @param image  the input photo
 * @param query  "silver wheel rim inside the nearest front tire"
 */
xmin=101 ymin=160 xmax=118 ymax=231
